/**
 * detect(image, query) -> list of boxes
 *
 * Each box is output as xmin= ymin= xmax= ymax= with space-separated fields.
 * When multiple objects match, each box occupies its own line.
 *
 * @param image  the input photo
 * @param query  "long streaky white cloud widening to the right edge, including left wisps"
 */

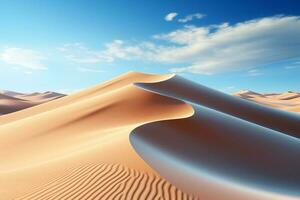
xmin=59 ymin=16 xmax=300 ymax=74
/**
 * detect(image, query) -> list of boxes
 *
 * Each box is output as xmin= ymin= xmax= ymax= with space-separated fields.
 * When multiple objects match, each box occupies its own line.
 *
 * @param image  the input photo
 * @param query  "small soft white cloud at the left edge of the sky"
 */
xmin=0 ymin=48 xmax=47 ymax=70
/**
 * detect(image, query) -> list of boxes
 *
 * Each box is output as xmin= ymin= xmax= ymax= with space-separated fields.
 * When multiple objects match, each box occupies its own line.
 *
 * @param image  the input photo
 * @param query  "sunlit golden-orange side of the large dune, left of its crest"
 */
xmin=0 ymin=73 xmax=194 ymax=200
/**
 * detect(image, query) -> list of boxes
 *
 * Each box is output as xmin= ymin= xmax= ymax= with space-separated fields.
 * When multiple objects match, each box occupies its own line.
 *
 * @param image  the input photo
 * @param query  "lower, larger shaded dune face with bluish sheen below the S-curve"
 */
xmin=131 ymin=106 xmax=300 ymax=200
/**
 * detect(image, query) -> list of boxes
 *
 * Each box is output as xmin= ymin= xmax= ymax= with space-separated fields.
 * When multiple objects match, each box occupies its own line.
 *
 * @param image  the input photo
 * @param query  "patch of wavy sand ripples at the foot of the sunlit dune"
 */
xmin=16 ymin=164 xmax=197 ymax=200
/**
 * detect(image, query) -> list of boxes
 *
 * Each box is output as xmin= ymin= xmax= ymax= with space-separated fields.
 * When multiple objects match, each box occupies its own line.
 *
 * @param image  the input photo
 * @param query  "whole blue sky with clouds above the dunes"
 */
xmin=0 ymin=0 xmax=300 ymax=93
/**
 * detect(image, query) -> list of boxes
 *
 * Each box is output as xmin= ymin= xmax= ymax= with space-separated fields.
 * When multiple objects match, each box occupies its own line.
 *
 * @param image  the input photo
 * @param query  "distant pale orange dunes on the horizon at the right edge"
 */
xmin=234 ymin=91 xmax=300 ymax=112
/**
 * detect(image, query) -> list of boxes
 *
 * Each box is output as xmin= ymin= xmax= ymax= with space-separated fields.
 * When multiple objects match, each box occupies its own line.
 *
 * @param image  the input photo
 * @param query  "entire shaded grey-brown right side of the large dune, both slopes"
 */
xmin=130 ymin=76 xmax=300 ymax=200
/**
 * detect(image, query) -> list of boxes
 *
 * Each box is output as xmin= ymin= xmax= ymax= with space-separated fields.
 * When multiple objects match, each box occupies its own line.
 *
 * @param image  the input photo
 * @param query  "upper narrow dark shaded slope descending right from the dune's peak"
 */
xmin=136 ymin=76 xmax=300 ymax=138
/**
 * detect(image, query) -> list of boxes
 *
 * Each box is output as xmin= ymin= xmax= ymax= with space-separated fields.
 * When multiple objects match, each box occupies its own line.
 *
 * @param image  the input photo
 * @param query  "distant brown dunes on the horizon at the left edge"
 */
xmin=0 ymin=91 xmax=65 ymax=115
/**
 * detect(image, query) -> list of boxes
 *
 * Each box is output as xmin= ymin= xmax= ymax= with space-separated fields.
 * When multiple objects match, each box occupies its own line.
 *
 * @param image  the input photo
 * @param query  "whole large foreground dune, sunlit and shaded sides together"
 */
xmin=0 ymin=72 xmax=300 ymax=200
